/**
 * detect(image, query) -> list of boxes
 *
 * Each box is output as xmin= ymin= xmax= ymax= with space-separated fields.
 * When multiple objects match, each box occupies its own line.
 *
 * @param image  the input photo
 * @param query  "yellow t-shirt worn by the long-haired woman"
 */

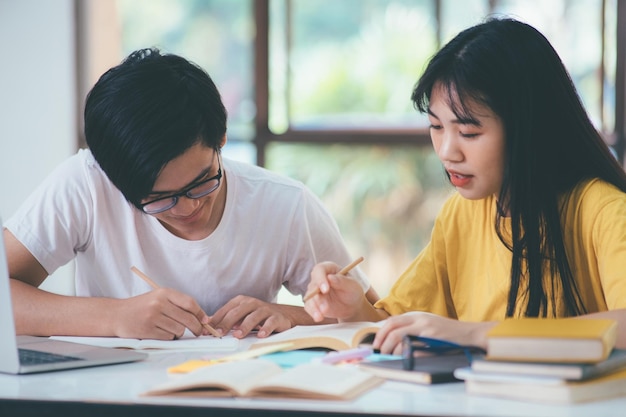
xmin=376 ymin=180 xmax=626 ymax=321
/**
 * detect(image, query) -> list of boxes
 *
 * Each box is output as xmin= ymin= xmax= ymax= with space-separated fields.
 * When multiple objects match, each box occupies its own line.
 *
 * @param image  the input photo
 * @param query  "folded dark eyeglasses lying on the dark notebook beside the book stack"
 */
xmin=402 ymin=335 xmax=487 ymax=371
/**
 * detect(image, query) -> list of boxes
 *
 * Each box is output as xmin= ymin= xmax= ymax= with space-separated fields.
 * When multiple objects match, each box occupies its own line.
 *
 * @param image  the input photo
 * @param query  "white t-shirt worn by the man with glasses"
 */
xmin=5 ymin=150 xmax=369 ymax=315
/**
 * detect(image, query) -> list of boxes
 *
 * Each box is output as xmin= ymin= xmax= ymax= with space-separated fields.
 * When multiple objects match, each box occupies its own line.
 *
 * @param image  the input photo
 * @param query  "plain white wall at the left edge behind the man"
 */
xmin=0 ymin=0 xmax=78 ymax=292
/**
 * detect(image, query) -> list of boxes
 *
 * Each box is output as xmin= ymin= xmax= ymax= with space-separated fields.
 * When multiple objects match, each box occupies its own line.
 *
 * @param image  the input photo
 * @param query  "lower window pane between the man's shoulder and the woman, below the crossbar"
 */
xmin=267 ymin=144 xmax=453 ymax=295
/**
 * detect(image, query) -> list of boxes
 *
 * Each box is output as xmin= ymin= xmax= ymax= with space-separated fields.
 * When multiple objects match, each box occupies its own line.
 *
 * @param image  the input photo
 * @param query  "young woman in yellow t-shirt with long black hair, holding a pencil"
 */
xmin=305 ymin=19 xmax=626 ymax=353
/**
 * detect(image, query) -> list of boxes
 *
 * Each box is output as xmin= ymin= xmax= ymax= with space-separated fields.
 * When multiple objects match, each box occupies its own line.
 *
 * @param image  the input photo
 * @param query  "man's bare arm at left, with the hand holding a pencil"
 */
xmin=4 ymin=229 xmax=209 ymax=339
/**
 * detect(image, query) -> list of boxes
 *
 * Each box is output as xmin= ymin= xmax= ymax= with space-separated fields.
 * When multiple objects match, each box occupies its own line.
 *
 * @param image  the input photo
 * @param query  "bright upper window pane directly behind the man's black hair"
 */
xmin=117 ymin=0 xmax=255 ymax=151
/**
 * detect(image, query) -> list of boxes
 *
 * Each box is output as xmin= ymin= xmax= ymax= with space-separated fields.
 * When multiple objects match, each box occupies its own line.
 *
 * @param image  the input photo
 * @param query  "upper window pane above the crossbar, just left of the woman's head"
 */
xmin=270 ymin=0 xmax=436 ymax=133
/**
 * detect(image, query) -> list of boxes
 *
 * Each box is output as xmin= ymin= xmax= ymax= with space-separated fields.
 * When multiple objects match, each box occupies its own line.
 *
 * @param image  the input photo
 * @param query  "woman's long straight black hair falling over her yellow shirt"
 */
xmin=411 ymin=18 xmax=626 ymax=317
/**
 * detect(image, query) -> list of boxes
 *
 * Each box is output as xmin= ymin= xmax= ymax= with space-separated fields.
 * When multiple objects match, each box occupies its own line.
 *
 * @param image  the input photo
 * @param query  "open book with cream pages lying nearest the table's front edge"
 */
xmin=143 ymin=359 xmax=384 ymax=400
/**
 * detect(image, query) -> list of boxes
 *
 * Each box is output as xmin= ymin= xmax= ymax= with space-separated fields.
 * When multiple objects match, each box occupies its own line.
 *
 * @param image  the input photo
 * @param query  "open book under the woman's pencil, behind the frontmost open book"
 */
xmin=251 ymin=321 xmax=384 ymax=350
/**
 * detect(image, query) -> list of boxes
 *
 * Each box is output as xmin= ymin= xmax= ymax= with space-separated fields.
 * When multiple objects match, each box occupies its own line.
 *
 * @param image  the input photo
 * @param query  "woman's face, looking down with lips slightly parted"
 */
xmin=428 ymin=84 xmax=505 ymax=200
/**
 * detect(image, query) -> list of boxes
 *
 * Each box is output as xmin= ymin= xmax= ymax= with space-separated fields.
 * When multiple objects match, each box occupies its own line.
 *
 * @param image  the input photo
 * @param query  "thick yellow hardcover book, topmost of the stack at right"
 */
xmin=487 ymin=318 xmax=617 ymax=363
